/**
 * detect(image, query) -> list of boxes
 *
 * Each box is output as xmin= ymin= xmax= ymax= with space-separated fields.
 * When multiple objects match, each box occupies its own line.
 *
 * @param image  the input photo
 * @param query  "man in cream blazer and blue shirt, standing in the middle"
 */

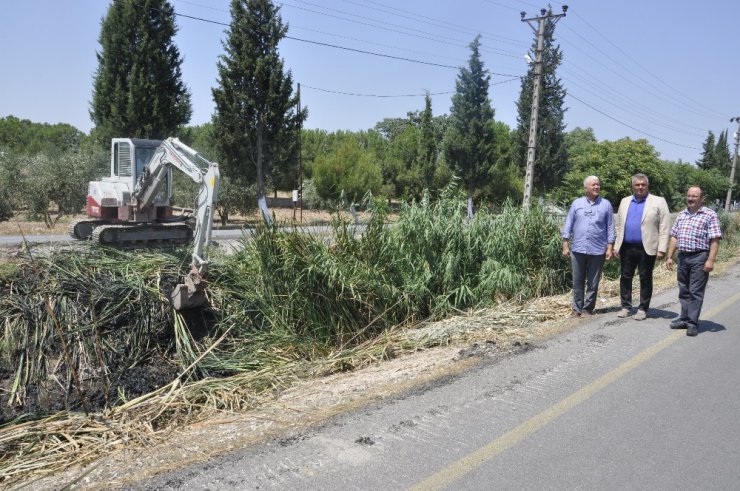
xmin=614 ymin=174 xmax=671 ymax=320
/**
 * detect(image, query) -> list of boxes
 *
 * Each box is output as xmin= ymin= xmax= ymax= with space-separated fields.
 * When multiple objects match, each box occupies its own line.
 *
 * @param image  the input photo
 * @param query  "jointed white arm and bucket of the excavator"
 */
xmin=131 ymin=138 xmax=220 ymax=310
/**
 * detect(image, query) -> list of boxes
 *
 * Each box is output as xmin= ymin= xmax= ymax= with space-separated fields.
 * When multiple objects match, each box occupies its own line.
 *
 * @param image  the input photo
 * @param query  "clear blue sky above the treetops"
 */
xmin=0 ymin=0 xmax=740 ymax=162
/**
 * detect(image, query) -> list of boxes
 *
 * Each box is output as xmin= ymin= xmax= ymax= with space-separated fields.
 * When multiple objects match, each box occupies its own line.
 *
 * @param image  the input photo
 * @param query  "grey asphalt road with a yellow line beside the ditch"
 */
xmin=128 ymin=266 xmax=740 ymax=490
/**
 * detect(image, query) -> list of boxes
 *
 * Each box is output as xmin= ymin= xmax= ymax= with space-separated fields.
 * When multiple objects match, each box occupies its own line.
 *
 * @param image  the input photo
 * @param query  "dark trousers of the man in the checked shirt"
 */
xmin=676 ymin=251 xmax=709 ymax=326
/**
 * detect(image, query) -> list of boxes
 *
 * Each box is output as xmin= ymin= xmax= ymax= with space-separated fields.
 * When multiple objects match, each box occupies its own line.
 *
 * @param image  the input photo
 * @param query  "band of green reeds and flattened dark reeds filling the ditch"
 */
xmin=0 ymin=189 xmax=570 ymax=420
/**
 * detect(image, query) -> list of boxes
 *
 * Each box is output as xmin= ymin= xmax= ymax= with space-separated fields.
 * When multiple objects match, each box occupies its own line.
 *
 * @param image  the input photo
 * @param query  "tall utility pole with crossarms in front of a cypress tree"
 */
xmin=520 ymin=5 xmax=568 ymax=208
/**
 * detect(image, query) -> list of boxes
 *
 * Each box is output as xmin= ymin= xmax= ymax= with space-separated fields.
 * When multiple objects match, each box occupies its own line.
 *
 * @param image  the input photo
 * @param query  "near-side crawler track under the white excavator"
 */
xmin=92 ymin=222 xmax=193 ymax=247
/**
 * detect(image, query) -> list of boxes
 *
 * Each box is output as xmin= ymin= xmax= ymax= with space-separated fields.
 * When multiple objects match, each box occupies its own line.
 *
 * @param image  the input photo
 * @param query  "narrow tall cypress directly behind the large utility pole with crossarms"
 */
xmin=515 ymin=11 xmax=569 ymax=194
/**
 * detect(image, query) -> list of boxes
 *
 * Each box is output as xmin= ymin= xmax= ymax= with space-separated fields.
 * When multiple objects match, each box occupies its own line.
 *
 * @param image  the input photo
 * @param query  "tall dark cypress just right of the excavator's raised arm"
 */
xmin=212 ymin=0 xmax=308 ymax=216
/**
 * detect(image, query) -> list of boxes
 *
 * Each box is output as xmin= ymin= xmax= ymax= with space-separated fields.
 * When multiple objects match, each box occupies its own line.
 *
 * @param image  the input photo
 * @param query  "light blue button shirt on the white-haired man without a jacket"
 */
xmin=563 ymin=196 xmax=616 ymax=256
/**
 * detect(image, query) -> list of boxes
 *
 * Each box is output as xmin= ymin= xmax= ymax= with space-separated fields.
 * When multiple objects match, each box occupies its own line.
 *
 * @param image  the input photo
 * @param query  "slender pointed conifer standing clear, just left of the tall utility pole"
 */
xmin=443 ymin=36 xmax=496 ymax=216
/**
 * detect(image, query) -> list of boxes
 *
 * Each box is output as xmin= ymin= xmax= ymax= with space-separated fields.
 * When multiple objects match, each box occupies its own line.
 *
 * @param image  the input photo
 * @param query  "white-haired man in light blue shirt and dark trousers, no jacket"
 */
xmin=562 ymin=176 xmax=615 ymax=317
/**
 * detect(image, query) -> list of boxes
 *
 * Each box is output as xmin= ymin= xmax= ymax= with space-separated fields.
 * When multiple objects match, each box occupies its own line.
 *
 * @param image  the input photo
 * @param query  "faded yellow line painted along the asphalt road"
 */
xmin=410 ymin=293 xmax=740 ymax=491
